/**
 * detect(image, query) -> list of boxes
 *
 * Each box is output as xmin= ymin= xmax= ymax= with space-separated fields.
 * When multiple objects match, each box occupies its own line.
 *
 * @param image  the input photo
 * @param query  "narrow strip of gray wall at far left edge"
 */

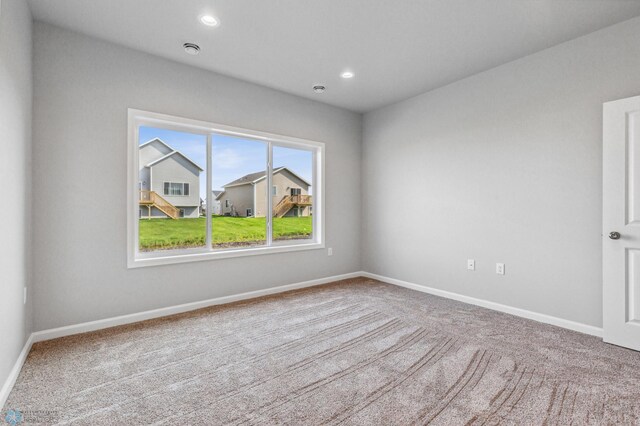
xmin=0 ymin=0 xmax=32 ymax=386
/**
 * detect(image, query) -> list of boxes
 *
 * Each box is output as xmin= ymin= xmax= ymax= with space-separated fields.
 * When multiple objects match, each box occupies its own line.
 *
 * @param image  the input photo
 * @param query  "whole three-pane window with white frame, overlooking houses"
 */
xmin=128 ymin=110 xmax=324 ymax=267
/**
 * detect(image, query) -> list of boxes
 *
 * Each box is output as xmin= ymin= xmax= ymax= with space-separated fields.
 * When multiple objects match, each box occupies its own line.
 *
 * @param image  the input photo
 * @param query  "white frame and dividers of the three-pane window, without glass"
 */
xmin=127 ymin=109 xmax=325 ymax=268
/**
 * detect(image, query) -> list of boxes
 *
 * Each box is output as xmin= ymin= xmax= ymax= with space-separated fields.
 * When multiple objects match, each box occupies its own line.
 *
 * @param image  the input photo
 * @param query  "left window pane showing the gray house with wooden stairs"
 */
xmin=138 ymin=126 xmax=207 ymax=251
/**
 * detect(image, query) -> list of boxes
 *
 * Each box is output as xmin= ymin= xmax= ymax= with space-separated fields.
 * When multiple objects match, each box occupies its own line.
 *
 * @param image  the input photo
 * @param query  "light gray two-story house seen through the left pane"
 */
xmin=138 ymin=138 xmax=204 ymax=219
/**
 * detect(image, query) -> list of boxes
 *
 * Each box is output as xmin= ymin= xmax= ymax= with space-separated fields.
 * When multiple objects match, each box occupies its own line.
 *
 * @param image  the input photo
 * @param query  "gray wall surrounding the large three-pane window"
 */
xmin=33 ymin=23 xmax=362 ymax=330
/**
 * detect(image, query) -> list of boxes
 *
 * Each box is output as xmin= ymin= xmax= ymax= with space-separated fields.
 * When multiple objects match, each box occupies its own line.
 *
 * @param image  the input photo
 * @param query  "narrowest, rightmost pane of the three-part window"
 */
xmin=272 ymin=146 xmax=313 ymax=241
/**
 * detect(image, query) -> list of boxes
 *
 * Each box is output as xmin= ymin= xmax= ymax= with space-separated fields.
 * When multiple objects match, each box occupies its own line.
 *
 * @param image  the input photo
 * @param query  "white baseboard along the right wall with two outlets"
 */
xmin=361 ymin=272 xmax=602 ymax=337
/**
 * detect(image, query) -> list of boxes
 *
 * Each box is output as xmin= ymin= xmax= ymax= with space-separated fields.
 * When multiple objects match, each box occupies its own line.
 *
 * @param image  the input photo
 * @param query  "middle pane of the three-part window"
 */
xmin=211 ymin=134 xmax=268 ymax=249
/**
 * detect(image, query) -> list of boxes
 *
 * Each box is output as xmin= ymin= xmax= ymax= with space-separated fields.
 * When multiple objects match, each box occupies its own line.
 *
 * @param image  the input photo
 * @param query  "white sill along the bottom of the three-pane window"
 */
xmin=128 ymin=242 xmax=324 ymax=269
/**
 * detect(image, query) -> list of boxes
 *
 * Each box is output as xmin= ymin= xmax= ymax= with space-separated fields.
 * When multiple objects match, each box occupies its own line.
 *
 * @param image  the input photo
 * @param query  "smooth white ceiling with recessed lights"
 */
xmin=29 ymin=0 xmax=640 ymax=112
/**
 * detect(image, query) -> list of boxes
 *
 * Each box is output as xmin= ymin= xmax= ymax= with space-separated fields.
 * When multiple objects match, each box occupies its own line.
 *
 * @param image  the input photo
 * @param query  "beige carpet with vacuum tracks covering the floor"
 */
xmin=4 ymin=278 xmax=640 ymax=425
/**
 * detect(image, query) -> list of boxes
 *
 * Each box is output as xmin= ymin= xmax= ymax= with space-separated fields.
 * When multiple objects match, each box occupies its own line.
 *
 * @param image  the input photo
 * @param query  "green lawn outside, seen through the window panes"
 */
xmin=140 ymin=216 xmax=312 ymax=251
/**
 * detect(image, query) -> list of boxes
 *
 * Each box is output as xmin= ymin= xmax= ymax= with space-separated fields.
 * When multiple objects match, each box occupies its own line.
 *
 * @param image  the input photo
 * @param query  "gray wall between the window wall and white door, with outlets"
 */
xmin=362 ymin=19 xmax=640 ymax=326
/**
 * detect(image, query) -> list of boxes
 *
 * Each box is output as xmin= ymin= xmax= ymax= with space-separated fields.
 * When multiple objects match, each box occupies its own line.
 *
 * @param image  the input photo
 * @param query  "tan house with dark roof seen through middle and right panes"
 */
xmin=215 ymin=167 xmax=312 ymax=217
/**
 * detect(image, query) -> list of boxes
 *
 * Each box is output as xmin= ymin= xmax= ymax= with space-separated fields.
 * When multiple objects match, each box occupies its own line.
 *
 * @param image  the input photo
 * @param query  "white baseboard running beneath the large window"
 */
xmin=32 ymin=272 xmax=363 ymax=343
